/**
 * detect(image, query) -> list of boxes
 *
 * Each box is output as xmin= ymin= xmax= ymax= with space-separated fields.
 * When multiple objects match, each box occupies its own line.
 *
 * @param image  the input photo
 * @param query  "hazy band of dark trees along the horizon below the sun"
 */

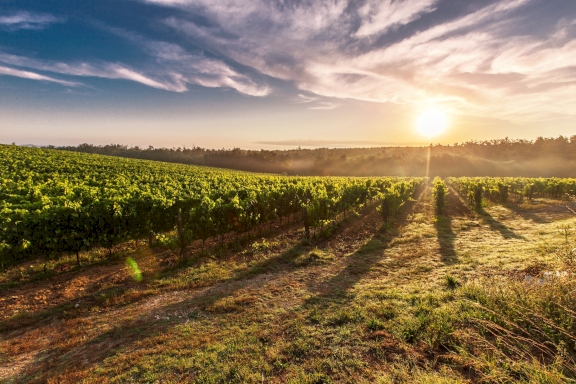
xmin=53 ymin=135 xmax=576 ymax=177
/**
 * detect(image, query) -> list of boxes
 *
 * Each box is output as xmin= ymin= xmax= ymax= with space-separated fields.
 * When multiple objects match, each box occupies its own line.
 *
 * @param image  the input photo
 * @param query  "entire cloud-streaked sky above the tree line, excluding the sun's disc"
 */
xmin=0 ymin=0 xmax=576 ymax=149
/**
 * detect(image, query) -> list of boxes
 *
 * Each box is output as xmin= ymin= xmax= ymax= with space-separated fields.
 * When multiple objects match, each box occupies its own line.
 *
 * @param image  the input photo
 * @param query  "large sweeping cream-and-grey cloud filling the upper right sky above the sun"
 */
xmin=146 ymin=0 xmax=576 ymax=120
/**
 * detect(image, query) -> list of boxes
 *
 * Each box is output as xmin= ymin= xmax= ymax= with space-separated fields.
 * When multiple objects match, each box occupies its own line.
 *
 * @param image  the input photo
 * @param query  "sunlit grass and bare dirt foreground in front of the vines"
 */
xmin=0 ymin=185 xmax=576 ymax=383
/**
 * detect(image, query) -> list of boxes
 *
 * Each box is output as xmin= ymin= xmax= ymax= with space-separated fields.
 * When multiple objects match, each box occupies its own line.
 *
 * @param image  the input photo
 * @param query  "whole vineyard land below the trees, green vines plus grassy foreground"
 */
xmin=0 ymin=146 xmax=576 ymax=383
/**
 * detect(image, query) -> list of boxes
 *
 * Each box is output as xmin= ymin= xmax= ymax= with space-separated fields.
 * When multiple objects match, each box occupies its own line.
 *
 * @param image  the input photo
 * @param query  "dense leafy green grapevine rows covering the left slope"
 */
xmin=0 ymin=146 xmax=422 ymax=265
